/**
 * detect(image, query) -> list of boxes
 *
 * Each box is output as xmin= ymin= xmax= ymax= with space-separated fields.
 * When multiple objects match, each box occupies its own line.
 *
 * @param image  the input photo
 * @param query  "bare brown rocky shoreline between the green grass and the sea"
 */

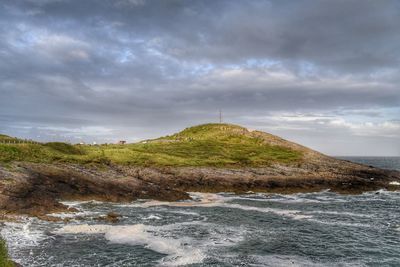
xmin=0 ymin=156 xmax=400 ymax=220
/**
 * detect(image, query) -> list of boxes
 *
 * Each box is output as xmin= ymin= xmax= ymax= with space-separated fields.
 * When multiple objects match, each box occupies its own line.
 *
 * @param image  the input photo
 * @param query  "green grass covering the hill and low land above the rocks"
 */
xmin=0 ymin=124 xmax=304 ymax=167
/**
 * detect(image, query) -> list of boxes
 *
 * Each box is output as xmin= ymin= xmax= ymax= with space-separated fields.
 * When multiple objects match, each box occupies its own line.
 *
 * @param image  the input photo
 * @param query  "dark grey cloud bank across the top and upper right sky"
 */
xmin=5 ymin=0 xmax=400 ymax=72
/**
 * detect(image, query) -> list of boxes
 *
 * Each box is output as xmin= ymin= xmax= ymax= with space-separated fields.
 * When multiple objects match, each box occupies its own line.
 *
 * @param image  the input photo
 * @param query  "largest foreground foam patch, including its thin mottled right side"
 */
xmin=54 ymin=221 xmax=247 ymax=266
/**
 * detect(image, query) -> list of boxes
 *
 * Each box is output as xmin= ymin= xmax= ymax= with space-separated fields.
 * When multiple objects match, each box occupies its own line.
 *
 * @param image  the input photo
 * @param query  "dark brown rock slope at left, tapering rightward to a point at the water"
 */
xmin=0 ymin=163 xmax=189 ymax=219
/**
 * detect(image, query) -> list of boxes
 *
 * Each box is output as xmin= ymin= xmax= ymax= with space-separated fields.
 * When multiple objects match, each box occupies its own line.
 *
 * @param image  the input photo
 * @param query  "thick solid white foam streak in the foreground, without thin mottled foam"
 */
xmin=55 ymin=224 xmax=205 ymax=266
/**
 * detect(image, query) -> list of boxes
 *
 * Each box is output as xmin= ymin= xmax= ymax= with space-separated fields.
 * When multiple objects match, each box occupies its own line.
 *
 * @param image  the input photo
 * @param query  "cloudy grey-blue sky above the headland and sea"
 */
xmin=0 ymin=0 xmax=400 ymax=156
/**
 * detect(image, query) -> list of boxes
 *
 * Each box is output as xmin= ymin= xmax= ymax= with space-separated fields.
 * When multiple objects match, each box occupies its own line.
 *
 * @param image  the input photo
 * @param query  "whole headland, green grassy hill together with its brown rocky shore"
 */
xmin=0 ymin=124 xmax=400 ymax=220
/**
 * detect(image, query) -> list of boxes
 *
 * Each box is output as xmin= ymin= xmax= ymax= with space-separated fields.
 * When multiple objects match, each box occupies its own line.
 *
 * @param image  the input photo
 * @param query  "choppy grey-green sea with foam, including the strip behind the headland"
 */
xmin=1 ymin=157 xmax=400 ymax=267
